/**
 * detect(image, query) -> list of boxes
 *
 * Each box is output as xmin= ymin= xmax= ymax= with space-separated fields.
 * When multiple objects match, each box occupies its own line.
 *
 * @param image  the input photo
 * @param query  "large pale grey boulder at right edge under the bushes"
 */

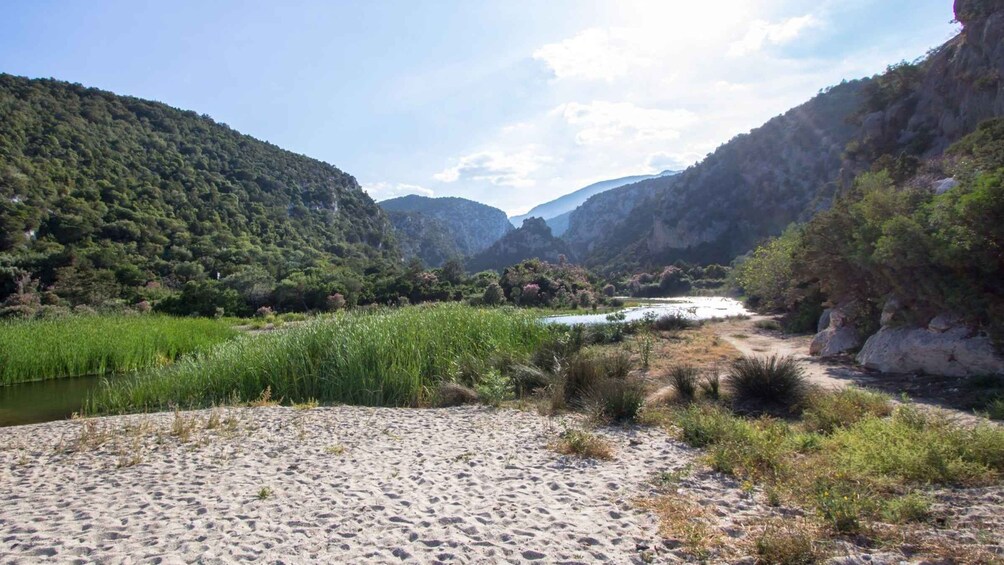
xmin=857 ymin=325 xmax=1004 ymax=376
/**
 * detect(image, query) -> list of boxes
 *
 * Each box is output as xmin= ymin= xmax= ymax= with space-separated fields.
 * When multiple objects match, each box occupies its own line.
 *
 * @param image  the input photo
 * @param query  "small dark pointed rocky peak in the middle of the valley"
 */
xmin=467 ymin=218 xmax=571 ymax=272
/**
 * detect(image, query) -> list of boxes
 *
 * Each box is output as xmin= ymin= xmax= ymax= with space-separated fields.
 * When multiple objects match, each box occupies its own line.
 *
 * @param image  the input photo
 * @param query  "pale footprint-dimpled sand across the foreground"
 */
xmin=0 ymin=406 xmax=756 ymax=563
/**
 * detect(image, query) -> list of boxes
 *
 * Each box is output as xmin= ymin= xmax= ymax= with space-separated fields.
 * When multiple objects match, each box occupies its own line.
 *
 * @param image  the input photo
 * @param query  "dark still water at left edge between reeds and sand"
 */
xmin=0 ymin=375 xmax=109 ymax=427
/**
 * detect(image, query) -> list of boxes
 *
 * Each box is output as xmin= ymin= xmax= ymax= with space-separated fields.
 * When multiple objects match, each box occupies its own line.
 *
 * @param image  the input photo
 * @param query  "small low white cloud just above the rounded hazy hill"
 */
xmin=433 ymin=148 xmax=551 ymax=188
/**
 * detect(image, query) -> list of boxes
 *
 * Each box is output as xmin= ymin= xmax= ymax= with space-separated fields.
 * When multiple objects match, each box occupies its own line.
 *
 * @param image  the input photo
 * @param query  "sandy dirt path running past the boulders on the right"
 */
xmin=714 ymin=316 xmax=991 ymax=423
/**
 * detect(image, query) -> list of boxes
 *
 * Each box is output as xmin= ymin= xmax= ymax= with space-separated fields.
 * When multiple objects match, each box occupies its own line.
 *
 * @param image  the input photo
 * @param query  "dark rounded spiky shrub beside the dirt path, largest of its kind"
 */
xmin=727 ymin=355 xmax=807 ymax=411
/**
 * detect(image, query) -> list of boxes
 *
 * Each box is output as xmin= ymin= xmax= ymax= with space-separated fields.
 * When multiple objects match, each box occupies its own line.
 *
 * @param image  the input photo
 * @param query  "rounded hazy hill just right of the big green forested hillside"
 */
xmin=380 ymin=195 xmax=514 ymax=267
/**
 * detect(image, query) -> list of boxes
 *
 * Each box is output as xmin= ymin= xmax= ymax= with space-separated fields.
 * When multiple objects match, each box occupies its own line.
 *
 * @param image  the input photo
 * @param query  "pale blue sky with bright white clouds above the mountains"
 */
xmin=0 ymin=0 xmax=959 ymax=215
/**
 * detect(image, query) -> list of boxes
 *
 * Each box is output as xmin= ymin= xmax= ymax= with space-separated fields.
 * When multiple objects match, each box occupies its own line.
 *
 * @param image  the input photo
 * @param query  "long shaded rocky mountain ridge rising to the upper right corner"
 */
xmin=563 ymin=0 xmax=1004 ymax=272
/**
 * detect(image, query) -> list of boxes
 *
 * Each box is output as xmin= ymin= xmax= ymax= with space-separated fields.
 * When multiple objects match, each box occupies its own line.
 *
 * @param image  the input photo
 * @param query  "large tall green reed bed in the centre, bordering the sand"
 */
xmin=88 ymin=304 xmax=551 ymax=413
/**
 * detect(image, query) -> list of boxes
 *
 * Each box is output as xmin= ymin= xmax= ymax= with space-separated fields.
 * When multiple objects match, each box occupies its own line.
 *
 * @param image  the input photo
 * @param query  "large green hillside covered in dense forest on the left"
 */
xmin=0 ymin=74 xmax=400 ymax=303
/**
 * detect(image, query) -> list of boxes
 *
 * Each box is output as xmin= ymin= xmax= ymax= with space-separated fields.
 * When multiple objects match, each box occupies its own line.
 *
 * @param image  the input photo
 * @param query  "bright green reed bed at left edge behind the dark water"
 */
xmin=0 ymin=315 xmax=238 ymax=384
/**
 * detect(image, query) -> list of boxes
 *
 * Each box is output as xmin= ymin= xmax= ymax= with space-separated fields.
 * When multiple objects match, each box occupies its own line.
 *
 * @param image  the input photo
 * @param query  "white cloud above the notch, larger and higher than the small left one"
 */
xmin=553 ymin=101 xmax=697 ymax=145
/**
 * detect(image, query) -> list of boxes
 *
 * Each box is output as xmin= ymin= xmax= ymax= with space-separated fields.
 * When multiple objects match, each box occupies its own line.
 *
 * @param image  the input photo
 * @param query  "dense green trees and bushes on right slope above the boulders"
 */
xmin=737 ymin=119 xmax=1004 ymax=338
